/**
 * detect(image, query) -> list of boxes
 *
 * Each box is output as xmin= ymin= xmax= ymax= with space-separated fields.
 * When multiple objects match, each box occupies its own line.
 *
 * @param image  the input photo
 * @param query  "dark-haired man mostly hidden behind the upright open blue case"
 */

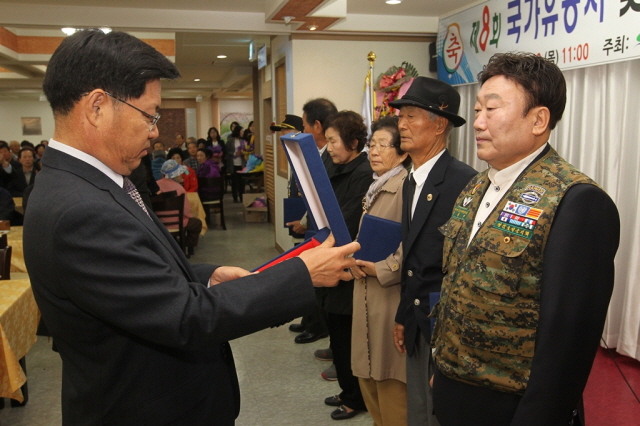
xmin=286 ymin=98 xmax=338 ymax=344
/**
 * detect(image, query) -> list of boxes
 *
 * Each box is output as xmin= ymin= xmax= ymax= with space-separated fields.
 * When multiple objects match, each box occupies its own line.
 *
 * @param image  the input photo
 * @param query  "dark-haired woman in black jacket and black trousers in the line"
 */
xmin=320 ymin=111 xmax=373 ymax=420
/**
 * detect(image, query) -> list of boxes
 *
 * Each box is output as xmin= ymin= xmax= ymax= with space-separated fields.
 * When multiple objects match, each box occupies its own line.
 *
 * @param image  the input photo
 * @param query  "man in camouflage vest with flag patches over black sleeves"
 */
xmin=432 ymin=53 xmax=620 ymax=426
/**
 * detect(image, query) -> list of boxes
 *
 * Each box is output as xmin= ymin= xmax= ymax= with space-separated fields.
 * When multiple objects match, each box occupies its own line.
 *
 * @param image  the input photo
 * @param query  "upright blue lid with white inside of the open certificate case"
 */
xmin=280 ymin=133 xmax=351 ymax=246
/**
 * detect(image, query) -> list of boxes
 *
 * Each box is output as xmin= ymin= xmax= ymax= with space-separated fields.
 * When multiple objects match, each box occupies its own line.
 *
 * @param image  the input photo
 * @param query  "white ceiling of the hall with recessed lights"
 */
xmin=0 ymin=0 xmax=477 ymax=100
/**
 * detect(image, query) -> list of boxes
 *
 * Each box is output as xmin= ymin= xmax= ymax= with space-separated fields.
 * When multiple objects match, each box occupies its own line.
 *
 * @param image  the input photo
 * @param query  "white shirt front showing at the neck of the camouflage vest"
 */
xmin=467 ymin=144 xmax=547 ymax=246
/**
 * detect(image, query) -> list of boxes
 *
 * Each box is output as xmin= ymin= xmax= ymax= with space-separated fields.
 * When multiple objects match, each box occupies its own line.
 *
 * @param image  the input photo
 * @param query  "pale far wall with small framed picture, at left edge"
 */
xmin=0 ymin=101 xmax=53 ymax=145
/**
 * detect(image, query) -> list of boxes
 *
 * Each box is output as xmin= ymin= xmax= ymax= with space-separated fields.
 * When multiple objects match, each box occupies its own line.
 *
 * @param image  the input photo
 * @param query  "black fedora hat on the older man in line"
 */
xmin=389 ymin=77 xmax=467 ymax=127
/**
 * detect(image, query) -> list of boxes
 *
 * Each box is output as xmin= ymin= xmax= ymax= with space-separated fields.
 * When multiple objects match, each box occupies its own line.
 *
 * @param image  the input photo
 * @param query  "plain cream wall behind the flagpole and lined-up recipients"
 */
xmin=272 ymin=40 xmax=436 ymax=253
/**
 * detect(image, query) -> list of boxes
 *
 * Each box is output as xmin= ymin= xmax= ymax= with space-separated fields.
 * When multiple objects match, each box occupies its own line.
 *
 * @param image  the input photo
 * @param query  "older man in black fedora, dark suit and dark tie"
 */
xmin=390 ymin=77 xmax=476 ymax=426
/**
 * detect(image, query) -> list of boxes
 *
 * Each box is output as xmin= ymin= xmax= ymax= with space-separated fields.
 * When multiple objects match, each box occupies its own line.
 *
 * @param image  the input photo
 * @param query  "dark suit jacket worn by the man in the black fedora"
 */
xmin=396 ymin=151 xmax=477 ymax=355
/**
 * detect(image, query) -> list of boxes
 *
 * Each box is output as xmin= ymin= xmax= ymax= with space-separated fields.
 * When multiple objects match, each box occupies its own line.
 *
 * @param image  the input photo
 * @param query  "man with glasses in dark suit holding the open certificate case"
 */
xmin=24 ymin=30 xmax=358 ymax=426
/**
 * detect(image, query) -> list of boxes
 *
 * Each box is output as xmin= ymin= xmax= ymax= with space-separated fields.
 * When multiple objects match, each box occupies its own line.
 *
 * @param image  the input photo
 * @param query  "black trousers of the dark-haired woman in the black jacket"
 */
xmin=327 ymin=312 xmax=367 ymax=410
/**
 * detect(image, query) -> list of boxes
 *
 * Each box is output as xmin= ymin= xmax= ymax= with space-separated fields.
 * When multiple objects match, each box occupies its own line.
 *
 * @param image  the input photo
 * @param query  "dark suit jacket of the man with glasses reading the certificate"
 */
xmin=24 ymin=148 xmax=315 ymax=426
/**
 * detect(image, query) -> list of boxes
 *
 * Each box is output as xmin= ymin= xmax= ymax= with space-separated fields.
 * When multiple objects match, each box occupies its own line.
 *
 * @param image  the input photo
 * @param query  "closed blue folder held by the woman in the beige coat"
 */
xmin=353 ymin=214 xmax=402 ymax=262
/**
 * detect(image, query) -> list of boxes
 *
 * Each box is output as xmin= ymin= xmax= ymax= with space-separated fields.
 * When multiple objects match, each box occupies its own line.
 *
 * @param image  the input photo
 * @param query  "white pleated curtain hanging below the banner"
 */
xmin=449 ymin=60 xmax=640 ymax=360
